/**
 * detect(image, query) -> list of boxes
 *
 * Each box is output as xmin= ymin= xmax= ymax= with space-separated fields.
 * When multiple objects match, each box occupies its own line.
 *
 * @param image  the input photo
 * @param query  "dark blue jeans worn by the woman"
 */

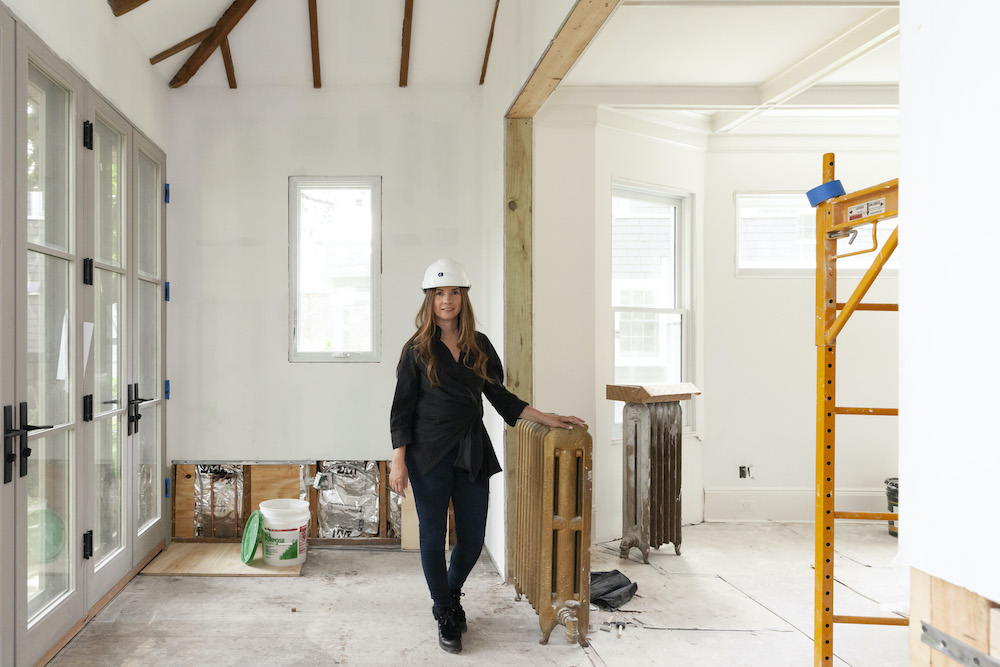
xmin=406 ymin=447 xmax=490 ymax=607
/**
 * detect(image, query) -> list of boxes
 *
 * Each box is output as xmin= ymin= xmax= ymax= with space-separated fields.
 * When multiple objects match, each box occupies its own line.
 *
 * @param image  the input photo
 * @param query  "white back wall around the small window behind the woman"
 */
xmin=168 ymin=86 xmax=482 ymax=461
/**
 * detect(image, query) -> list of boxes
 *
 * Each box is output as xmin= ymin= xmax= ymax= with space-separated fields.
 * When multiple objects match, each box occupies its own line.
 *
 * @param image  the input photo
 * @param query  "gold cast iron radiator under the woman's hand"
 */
xmin=511 ymin=419 xmax=593 ymax=646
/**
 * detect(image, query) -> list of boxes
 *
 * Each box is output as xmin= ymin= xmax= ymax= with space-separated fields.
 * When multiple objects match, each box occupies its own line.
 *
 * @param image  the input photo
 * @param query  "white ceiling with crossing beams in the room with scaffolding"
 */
xmin=549 ymin=0 xmax=899 ymax=134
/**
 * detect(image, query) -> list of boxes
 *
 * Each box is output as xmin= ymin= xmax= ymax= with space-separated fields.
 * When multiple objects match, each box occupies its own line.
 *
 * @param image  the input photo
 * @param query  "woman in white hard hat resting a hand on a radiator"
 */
xmin=389 ymin=259 xmax=584 ymax=653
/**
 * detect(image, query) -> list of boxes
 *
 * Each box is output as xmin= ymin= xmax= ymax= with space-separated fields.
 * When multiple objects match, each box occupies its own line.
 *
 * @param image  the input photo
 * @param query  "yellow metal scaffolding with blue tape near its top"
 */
xmin=809 ymin=153 xmax=909 ymax=667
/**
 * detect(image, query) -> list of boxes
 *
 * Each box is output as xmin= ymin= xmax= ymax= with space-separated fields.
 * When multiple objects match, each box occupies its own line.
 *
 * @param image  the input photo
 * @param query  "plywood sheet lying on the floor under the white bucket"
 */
xmin=142 ymin=542 xmax=302 ymax=577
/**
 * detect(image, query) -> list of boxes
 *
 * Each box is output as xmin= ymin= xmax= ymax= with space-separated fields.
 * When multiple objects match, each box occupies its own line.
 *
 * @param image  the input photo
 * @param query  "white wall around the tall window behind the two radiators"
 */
xmin=533 ymin=108 xmax=705 ymax=541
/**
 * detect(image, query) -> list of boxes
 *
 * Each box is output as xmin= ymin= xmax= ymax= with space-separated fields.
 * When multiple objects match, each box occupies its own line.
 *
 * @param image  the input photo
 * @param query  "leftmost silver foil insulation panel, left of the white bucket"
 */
xmin=194 ymin=464 xmax=243 ymax=537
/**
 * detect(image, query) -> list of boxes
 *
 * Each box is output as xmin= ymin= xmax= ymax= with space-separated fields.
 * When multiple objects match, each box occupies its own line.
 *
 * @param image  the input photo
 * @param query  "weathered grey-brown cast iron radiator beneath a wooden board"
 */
xmin=619 ymin=401 xmax=681 ymax=563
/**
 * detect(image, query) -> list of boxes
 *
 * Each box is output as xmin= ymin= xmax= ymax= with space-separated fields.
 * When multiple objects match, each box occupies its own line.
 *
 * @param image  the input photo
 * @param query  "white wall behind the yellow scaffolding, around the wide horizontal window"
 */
xmin=701 ymin=136 xmax=898 ymax=521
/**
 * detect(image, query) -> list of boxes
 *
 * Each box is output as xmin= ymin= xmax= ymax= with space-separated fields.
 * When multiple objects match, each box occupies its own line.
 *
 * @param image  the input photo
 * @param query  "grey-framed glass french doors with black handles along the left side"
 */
xmin=0 ymin=18 xmax=167 ymax=665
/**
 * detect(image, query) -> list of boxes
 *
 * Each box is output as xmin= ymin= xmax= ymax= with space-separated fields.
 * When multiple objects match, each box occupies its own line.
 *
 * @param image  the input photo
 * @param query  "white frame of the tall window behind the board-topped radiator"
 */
xmin=608 ymin=179 xmax=697 ymax=436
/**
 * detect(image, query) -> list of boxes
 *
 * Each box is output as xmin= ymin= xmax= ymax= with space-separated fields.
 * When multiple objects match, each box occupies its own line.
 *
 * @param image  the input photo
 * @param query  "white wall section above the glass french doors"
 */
xmin=4 ymin=0 xmax=170 ymax=147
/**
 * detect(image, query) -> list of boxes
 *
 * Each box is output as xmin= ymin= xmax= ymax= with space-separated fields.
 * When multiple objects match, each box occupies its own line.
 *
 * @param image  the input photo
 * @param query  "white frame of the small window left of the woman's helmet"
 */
xmin=288 ymin=176 xmax=382 ymax=363
